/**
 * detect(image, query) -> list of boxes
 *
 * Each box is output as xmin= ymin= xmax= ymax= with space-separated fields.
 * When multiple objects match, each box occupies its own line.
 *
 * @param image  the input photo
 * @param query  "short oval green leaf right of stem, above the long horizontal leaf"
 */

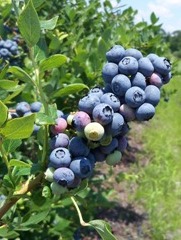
xmin=40 ymin=54 xmax=67 ymax=72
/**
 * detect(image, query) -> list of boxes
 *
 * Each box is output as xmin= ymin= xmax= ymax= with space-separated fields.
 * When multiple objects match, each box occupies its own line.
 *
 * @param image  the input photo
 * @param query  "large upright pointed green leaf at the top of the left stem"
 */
xmin=18 ymin=0 xmax=41 ymax=47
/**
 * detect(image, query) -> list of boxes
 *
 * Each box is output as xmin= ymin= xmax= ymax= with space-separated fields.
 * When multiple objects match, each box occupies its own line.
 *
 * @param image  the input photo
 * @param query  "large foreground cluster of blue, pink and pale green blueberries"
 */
xmin=45 ymin=45 xmax=171 ymax=194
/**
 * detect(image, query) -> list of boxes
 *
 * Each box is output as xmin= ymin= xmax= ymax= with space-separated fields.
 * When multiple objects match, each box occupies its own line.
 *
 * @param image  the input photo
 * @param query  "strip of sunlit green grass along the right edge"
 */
xmin=136 ymin=76 xmax=181 ymax=240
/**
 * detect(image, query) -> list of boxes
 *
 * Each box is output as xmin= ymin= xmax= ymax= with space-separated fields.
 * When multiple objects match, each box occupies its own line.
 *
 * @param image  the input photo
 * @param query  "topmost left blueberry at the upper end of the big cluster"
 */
xmin=106 ymin=45 xmax=125 ymax=63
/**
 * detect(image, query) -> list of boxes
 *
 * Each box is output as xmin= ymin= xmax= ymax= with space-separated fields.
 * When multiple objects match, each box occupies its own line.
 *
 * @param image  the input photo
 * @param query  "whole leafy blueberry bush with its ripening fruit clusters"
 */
xmin=0 ymin=0 xmax=172 ymax=240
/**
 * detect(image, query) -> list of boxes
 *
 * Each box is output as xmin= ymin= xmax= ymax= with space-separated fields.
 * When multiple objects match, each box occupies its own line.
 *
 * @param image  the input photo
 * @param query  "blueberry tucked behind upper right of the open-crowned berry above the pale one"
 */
xmin=100 ymin=92 xmax=120 ymax=111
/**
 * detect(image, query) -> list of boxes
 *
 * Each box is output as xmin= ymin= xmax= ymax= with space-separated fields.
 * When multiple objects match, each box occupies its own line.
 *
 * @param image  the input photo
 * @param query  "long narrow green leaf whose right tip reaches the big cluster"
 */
xmin=53 ymin=83 xmax=89 ymax=97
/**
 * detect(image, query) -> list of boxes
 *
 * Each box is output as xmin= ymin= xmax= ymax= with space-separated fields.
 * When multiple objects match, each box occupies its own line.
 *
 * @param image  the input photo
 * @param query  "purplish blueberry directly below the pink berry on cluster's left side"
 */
xmin=50 ymin=133 xmax=69 ymax=149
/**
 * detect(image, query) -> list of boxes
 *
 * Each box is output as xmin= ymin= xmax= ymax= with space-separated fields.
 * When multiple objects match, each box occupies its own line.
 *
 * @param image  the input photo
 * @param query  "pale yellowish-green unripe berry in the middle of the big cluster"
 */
xmin=84 ymin=122 xmax=104 ymax=141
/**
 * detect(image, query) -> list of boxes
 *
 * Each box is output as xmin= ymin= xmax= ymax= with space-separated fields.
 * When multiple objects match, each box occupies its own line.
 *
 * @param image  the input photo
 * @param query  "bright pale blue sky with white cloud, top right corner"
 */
xmin=110 ymin=0 xmax=181 ymax=33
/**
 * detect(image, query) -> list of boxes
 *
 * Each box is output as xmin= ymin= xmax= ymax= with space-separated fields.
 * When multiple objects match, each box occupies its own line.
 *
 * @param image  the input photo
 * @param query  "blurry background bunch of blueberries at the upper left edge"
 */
xmin=0 ymin=39 xmax=19 ymax=65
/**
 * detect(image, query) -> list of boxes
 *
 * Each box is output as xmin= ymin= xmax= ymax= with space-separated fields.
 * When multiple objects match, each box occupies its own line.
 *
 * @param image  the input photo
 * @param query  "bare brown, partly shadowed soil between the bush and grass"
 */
xmin=81 ymin=123 xmax=152 ymax=240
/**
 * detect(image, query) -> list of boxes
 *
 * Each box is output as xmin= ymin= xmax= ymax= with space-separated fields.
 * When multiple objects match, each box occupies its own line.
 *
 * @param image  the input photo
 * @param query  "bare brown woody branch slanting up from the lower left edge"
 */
xmin=0 ymin=173 xmax=44 ymax=219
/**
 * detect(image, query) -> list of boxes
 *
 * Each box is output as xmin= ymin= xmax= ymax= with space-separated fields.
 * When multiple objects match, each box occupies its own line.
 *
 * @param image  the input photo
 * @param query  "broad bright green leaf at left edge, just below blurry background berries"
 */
xmin=0 ymin=114 xmax=35 ymax=139
